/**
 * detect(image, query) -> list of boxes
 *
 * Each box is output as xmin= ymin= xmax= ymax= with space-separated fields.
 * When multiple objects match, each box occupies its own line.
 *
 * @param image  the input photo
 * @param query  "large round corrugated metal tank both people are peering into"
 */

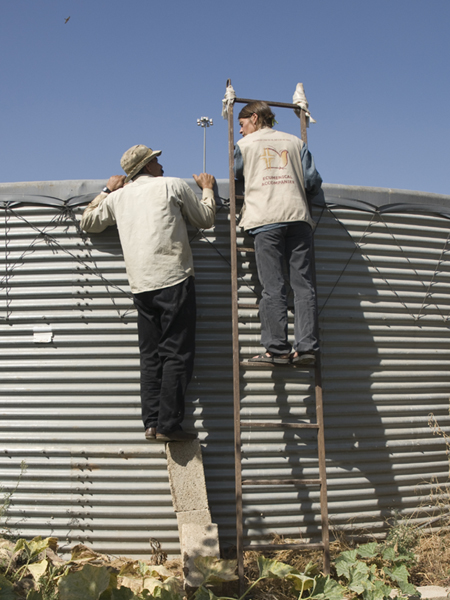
xmin=0 ymin=181 xmax=450 ymax=556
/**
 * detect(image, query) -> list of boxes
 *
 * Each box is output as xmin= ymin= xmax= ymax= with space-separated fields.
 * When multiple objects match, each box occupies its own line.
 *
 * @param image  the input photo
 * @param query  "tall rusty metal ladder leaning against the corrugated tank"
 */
xmin=227 ymin=80 xmax=330 ymax=584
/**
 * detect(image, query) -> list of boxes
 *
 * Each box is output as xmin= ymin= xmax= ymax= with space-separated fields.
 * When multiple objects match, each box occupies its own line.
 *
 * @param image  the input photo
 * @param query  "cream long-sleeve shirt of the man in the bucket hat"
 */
xmin=81 ymin=175 xmax=216 ymax=294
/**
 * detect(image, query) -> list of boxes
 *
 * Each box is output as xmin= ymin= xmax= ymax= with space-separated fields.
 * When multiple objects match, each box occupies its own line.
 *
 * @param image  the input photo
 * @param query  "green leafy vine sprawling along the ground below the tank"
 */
xmin=0 ymin=537 xmax=422 ymax=600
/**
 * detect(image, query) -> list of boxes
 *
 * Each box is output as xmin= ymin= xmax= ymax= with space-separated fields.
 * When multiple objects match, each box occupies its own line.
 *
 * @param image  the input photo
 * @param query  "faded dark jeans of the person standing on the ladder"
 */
xmin=255 ymin=222 xmax=319 ymax=354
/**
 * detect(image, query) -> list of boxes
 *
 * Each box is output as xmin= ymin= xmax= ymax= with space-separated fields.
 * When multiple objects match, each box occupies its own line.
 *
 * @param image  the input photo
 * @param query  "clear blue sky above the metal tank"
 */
xmin=0 ymin=0 xmax=450 ymax=194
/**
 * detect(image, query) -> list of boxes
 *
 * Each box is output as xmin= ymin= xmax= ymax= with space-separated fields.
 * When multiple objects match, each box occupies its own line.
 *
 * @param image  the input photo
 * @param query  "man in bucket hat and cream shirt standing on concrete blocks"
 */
xmin=81 ymin=144 xmax=216 ymax=441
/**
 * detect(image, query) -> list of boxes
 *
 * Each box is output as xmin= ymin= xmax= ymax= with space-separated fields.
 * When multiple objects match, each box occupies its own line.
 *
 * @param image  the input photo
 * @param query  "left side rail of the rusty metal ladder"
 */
xmin=228 ymin=97 xmax=244 ymax=587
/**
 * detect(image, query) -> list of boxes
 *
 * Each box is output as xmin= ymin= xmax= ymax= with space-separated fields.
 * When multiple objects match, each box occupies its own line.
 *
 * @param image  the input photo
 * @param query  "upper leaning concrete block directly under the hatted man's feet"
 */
xmin=166 ymin=440 xmax=208 ymax=512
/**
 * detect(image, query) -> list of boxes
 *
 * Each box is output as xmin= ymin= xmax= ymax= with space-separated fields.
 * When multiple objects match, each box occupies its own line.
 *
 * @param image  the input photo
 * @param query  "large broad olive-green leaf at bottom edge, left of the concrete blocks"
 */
xmin=58 ymin=564 xmax=109 ymax=600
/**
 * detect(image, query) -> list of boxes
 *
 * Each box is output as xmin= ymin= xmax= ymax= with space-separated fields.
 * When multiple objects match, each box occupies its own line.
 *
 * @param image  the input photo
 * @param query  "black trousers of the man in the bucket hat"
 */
xmin=134 ymin=277 xmax=196 ymax=433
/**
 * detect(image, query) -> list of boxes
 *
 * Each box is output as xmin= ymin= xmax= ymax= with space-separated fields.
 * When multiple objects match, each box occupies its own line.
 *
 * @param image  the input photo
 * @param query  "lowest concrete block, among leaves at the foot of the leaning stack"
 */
xmin=181 ymin=523 xmax=220 ymax=587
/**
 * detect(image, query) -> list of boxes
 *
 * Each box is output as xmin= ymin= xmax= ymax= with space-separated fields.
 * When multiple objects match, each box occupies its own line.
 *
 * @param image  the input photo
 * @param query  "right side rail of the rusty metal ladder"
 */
xmin=300 ymin=109 xmax=330 ymax=575
